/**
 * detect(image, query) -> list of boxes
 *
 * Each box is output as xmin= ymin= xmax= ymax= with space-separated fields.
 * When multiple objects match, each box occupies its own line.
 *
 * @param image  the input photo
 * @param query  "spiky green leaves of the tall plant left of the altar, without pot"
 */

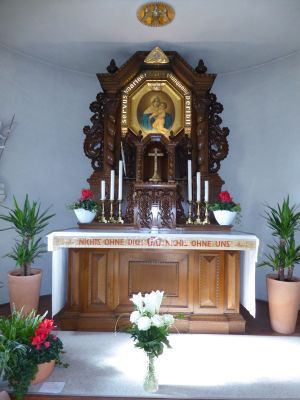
xmin=0 ymin=195 xmax=55 ymax=276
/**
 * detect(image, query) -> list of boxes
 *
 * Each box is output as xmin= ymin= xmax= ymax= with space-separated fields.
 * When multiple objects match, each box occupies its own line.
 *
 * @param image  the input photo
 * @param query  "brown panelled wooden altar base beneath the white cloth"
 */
xmin=56 ymin=248 xmax=245 ymax=333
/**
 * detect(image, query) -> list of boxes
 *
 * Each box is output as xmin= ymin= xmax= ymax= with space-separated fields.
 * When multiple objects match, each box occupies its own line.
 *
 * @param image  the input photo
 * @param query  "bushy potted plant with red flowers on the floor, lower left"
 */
xmin=0 ymin=310 xmax=68 ymax=400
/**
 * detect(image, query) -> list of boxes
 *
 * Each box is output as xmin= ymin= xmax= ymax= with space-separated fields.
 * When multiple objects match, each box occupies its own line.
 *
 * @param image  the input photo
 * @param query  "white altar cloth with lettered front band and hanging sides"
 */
xmin=47 ymin=229 xmax=259 ymax=317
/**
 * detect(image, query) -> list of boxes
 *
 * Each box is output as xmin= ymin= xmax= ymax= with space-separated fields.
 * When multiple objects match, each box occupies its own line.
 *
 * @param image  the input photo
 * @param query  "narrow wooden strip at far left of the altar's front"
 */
xmin=68 ymin=249 xmax=81 ymax=310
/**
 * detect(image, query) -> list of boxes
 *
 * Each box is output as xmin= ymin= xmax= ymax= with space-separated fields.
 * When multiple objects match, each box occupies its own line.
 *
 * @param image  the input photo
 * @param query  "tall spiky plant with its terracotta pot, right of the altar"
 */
xmin=259 ymin=196 xmax=300 ymax=334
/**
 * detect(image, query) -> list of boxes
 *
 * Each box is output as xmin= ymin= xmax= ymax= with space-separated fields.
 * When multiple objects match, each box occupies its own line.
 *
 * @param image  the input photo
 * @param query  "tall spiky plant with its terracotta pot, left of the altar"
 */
xmin=0 ymin=195 xmax=54 ymax=313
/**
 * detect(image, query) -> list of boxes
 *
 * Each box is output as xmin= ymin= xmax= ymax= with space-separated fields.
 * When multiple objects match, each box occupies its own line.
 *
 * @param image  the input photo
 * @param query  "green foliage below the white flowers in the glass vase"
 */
xmin=129 ymin=325 xmax=171 ymax=357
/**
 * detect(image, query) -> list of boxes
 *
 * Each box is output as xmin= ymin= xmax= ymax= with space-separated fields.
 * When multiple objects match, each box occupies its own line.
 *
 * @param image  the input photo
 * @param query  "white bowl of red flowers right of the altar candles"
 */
xmin=208 ymin=191 xmax=241 ymax=225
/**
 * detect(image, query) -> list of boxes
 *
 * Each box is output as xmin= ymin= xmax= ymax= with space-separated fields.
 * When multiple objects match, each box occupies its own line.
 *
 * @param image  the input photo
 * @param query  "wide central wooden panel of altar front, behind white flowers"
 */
xmin=115 ymin=250 xmax=192 ymax=312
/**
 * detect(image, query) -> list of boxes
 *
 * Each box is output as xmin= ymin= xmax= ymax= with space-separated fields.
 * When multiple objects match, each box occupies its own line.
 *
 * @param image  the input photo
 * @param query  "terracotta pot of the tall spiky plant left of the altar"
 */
xmin=8 ymin=268 xmax=42 ymax=314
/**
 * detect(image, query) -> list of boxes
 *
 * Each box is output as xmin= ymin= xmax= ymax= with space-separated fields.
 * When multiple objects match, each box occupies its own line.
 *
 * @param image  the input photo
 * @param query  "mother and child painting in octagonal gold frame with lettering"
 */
xmin=121 ymin=71 xmax=191 ymax=138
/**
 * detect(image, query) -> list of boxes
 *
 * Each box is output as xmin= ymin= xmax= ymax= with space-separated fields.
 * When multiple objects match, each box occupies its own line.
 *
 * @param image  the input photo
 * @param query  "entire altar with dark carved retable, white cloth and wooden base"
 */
xmin=48 ymin=47 xmax=258 ymax=333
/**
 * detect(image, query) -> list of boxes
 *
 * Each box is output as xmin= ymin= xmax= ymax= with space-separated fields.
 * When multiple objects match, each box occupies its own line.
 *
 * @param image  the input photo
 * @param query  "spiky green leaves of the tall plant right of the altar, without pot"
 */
xmin=259 ymin=196 xmax=300 ymax=281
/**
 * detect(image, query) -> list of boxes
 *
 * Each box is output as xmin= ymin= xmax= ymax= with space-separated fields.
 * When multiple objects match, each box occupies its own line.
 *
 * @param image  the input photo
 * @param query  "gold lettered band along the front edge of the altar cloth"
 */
xmin=53 ymin=235 xmax=256 ymax=250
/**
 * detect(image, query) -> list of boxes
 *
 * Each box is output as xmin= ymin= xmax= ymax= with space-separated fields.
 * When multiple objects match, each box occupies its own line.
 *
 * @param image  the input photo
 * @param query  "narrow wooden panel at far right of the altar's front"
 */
xmin=225 ymin=251 xmax=240 ymax=313
